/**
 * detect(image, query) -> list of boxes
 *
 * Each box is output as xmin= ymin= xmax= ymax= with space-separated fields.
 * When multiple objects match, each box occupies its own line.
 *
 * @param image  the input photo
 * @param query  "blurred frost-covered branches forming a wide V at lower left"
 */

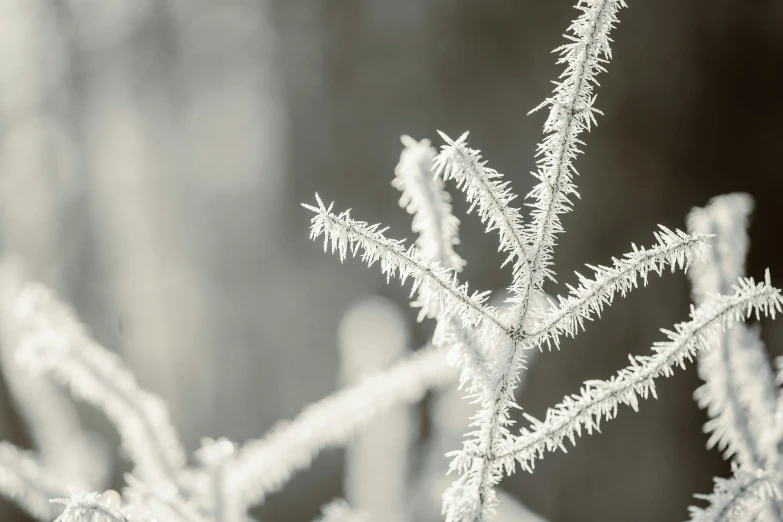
xmin=0 ymin=274 xmax=455 ymax=522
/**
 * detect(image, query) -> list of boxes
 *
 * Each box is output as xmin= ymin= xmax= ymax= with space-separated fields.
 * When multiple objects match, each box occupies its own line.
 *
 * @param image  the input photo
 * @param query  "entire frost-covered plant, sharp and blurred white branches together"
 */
xmin=0 ymin=0 xmax=783 ymax=522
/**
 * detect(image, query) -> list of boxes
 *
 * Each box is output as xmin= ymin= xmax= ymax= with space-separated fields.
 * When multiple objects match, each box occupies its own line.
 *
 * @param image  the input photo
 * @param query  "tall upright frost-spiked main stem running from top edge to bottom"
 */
xmin=444 ymin=4 xmax=625 ymax=522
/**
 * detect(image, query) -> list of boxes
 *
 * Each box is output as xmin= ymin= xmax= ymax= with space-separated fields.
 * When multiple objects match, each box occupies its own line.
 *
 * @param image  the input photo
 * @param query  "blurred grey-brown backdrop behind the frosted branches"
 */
xmin=0 ymin=0 xmax=783 ymax=522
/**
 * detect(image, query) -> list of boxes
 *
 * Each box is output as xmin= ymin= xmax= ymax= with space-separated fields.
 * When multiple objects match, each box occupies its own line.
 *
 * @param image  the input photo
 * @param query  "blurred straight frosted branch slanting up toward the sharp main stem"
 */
xmin=228 ymin=347 xmax=454 ymax=505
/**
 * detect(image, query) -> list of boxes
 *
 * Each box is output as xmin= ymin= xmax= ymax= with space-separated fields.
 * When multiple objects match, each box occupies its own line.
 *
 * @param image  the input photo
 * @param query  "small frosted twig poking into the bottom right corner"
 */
xmin=690 ymin=469 xmax=783 ymax=522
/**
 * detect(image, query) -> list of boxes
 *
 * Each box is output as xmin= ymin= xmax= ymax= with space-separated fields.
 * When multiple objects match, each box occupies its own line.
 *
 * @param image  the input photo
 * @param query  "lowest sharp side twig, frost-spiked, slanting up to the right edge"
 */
xmin=486 ymin=272 xmax=783 ymax=471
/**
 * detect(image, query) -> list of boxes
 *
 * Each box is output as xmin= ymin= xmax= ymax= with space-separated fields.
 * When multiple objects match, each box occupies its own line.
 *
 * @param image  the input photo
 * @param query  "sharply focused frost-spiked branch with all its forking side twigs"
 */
xmin=304 ymin=0 xmax=782 ymax=522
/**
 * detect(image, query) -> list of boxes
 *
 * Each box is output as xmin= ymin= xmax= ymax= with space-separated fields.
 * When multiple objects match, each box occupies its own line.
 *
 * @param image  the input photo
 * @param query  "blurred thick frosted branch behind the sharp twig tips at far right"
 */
xmin=688 ymin=193 xmax=779 ymax=469
